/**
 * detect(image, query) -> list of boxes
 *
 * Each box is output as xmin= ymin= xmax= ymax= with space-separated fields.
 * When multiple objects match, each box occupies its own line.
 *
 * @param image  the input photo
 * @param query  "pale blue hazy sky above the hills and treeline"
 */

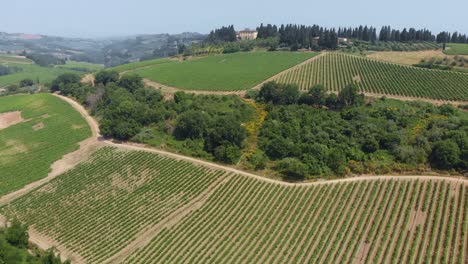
xmin=0 ymin=0 xmax=468 ymax=37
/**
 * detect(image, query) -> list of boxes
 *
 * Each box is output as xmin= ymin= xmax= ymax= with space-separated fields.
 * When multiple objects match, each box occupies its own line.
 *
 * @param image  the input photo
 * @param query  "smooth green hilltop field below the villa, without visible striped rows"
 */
xmin=132 ymin=52 xmax=317 ymax=91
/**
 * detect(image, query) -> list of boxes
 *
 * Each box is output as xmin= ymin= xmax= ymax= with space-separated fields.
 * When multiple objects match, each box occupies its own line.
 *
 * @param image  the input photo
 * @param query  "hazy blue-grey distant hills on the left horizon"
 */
xmin=0 ymin=32 xmax=206 ymax=66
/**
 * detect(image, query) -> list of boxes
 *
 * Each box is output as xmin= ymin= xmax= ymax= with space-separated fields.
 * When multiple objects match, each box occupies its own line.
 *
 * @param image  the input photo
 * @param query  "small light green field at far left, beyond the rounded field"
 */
xmin=0 ymin=63 xmax=83 ymax=88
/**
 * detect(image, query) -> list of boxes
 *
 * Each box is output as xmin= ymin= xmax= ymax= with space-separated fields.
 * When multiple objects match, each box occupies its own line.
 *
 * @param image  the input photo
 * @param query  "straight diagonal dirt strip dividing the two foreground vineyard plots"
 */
xmin=102 ymin=175 xmax=230 ymax=263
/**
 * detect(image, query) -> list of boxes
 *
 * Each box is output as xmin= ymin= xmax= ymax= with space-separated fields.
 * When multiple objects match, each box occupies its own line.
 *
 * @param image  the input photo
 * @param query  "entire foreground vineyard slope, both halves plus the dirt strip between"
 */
xmin=2 ymin=147 xmax=468 ymax=264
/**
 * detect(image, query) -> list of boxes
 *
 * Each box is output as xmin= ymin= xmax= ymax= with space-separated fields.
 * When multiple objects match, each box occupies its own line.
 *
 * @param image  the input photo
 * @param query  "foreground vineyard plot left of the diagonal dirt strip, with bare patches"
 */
xmin=3 ymin=147 xmax=229 ymax=263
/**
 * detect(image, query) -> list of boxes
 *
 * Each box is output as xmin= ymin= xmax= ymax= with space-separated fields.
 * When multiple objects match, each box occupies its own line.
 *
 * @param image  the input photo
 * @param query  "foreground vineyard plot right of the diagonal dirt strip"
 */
xmin=126 ymin=177 xmax=468 ymax=263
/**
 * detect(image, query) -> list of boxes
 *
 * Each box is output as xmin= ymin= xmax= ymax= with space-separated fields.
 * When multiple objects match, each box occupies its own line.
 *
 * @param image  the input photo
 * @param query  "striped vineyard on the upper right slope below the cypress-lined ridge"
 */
xmin=278 ymin=53 xmax=468 ymax=101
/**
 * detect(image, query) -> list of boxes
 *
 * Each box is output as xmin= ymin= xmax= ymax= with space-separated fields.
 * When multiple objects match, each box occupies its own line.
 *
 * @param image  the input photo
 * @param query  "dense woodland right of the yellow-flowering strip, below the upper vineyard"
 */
xmin=257 ymin=83 xmax=468 ymax=180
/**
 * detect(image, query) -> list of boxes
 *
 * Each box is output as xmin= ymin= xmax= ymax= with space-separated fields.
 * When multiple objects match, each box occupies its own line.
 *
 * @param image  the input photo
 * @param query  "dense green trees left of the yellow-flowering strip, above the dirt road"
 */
xmin=51 ymin=71 xmax=253 ymax=163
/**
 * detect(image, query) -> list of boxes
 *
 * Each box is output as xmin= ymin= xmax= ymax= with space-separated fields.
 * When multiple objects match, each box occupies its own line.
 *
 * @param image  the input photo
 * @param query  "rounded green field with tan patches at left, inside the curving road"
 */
xmin=0 ymin=94 xmax=91 ymax=195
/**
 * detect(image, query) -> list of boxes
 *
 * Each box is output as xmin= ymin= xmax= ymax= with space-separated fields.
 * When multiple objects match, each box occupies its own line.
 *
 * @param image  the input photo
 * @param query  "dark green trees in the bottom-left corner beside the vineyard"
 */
xmin=0 ymin=221 xmax=70 ymax=264
